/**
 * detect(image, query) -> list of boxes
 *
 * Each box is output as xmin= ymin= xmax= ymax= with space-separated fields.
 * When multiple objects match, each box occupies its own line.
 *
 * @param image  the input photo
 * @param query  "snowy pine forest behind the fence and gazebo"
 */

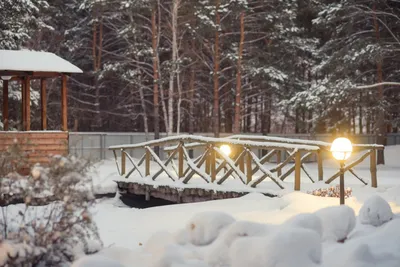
xmin=0 ymin=0 xmax=400 ymax=138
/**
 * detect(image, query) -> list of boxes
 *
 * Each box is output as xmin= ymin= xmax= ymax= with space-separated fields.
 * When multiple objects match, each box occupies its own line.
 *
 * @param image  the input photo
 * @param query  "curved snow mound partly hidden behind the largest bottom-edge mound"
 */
xmin=204 ymin=221 xmax=278 ymax=267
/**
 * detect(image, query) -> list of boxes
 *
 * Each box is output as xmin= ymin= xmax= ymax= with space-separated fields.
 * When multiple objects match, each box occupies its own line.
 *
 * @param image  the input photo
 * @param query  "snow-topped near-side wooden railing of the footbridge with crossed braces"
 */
xmin=109 ymin=135 xmax=320 ymax=190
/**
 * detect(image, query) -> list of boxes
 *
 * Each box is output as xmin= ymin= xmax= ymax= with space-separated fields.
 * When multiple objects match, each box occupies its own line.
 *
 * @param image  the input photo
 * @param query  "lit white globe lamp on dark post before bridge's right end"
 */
xmin=331 ymin=137 xmax=353 ymax=205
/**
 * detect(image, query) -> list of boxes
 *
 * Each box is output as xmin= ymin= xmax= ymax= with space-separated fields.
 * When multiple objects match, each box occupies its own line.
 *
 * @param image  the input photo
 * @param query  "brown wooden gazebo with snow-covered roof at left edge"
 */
xmin=0 ymin=50 xmax=82 ymax=166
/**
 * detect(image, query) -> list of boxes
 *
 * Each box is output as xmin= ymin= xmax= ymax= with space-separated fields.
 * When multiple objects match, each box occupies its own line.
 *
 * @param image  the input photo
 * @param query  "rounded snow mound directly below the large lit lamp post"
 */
xmin=314 ymin=205 xmax=356 ymax=242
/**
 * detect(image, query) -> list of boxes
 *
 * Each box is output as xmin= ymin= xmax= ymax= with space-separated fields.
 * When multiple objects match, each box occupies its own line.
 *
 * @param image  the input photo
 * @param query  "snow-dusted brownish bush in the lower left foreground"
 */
xmin=0 ymin=157 xmax=102 ymax=266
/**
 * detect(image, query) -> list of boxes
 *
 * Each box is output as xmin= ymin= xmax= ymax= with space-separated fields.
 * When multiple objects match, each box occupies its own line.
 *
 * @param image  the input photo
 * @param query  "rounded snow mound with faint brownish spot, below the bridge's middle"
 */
xmin=186 ymin=211 xmax=235 ymax=246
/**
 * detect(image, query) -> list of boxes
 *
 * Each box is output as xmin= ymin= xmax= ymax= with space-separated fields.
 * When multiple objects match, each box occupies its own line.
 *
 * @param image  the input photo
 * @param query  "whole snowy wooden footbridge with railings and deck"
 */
xmin=109 ymin=135 xmax=384 ymax=203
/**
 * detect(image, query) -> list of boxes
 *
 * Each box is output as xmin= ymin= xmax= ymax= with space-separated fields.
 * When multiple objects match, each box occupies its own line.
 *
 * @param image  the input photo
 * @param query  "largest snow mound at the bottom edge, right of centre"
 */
xmin=229 ymin=227 xmax=322 ymax=267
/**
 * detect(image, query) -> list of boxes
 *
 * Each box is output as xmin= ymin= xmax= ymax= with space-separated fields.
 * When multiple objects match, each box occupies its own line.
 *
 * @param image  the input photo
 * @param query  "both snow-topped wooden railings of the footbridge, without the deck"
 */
xmin=109 ymin=135 xmax=383 ymax=190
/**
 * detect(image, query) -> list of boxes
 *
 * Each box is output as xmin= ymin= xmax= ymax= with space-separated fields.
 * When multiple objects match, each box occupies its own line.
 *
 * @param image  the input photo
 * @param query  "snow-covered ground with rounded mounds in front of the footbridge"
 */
xmin=76 ymin=146 xmax=400 ymax=267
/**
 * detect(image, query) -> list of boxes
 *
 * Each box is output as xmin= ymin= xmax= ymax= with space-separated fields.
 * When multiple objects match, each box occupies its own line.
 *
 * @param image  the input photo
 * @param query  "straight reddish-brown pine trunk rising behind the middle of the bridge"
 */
xmin=213 ymin=0 xmax=220 ymax=137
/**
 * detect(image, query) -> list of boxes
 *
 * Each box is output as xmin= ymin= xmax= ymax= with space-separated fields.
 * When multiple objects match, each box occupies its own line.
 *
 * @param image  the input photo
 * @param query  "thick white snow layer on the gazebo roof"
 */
xmin=0 ymin=50 xmax=83 ymax=73
